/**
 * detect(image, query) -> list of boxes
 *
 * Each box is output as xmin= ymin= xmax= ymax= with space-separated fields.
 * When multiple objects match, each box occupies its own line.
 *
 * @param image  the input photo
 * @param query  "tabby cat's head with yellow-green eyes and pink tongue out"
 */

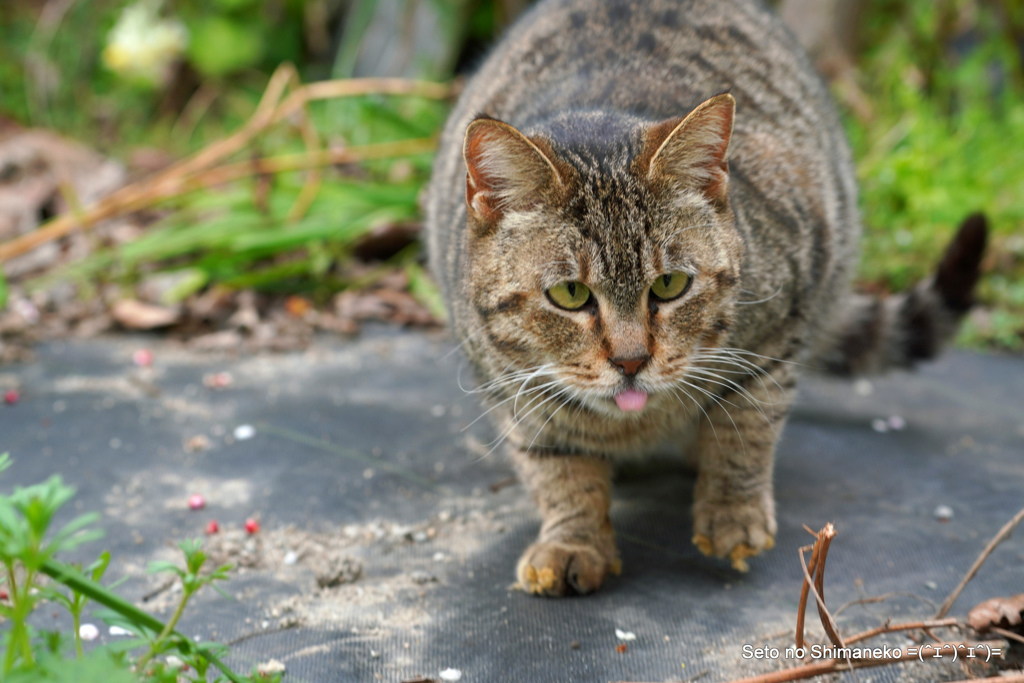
xmin=464 ymin=94 xmax=742 ymax=416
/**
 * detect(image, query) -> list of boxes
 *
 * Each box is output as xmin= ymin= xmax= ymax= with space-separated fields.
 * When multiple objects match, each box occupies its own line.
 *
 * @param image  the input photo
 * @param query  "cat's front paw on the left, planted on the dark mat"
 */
xmin=516 ymin=541 xmax=622 ymax=597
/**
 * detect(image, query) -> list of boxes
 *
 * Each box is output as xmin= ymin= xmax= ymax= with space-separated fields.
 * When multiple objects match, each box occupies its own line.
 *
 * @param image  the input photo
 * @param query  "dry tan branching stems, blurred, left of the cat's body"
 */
xmin=0 ymin=65 xmax=455 ymax=263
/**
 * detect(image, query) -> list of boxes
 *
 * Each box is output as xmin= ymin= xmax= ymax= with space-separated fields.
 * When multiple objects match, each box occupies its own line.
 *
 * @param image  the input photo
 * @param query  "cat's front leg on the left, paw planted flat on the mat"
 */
xmin=512 ymin=450 xmax=620 ymax=596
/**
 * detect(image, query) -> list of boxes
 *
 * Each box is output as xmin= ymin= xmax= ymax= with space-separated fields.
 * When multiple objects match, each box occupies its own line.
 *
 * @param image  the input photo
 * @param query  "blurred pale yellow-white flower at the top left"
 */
xmin=102 ymin=0 xmax=188 ymax=85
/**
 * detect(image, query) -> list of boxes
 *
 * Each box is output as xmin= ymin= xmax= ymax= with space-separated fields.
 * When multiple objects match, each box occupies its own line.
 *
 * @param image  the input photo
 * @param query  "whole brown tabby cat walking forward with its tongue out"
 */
xmin=428 ymin=0 xmax=986 ymax=596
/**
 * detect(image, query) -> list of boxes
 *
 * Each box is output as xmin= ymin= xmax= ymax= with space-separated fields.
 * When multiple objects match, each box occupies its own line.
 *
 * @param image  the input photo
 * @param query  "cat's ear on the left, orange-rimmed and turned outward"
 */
xmin=463 ymin=118 xmax=563 ymax=225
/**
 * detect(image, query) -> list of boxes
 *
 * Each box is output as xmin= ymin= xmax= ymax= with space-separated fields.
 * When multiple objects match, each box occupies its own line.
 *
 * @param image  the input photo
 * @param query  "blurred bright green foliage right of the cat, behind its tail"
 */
xmin=846 ymin=0 xmax=1024 ymax=349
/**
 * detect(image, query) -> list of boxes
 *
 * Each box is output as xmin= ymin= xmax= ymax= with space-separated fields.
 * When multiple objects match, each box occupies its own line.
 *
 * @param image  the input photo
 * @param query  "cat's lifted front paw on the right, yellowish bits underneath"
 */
xmin=693 ymin=494 xmax=777 ymax=571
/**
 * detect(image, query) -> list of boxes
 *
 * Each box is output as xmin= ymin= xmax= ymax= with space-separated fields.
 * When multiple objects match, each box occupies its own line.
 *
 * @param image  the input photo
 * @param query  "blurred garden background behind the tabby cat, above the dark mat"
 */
xmin=0 ymin=0 xmax=1024 ymax=362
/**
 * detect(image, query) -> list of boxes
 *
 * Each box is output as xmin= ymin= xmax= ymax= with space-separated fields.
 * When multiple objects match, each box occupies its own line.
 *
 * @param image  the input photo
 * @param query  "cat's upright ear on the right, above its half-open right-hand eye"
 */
xmin=647 ymin=93 xmax=736 ymax=204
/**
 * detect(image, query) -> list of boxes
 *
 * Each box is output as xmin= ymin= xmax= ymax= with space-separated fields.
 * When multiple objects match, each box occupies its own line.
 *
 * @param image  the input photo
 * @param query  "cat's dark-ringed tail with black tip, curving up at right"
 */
xmin=814 ymin=213 xmax=988 ymax=377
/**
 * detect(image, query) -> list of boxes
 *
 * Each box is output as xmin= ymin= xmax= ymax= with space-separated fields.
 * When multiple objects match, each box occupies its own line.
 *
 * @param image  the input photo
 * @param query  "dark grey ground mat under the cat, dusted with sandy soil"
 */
xmin=0 ymin=332 xmax=1024 ymax=683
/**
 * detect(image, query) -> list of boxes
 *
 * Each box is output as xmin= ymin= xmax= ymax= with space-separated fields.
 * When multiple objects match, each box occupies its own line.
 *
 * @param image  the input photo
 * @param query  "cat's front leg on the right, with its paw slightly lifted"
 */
xmin=693 ymin=364 xmax=796 ymax=571
